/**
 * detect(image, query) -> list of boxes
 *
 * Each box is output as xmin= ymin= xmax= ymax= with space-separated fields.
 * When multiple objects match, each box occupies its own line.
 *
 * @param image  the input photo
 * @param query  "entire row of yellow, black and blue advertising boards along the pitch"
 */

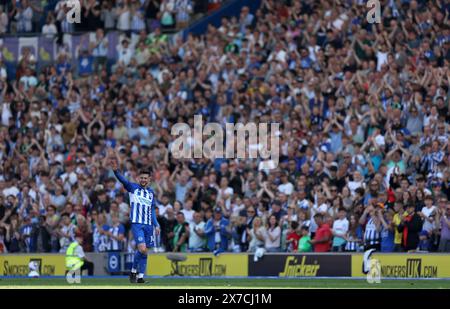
xmin=0 ymin=252 xmax=450 ymax=278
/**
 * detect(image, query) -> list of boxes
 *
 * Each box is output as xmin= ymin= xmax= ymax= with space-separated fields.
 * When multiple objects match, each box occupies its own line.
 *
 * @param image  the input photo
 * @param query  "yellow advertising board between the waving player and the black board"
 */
xmin=147 ymin=253 xmax=248 ymax=277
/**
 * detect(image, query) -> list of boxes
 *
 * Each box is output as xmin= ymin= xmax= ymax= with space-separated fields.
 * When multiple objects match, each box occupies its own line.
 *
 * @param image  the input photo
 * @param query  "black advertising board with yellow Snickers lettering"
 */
xmin=248 ymin=254 xmax=352 ymax=277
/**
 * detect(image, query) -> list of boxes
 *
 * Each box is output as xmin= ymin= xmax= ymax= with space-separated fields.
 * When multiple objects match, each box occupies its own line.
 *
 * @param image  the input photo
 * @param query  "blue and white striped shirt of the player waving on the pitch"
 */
xmin=114 ymin=171 xmax=159 ymax=227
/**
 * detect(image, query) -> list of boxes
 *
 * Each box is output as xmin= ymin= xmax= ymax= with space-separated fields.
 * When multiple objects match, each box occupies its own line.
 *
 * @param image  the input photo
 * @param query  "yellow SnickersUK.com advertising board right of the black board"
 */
xmin=352 ymin=253 xmax=450 ymax=278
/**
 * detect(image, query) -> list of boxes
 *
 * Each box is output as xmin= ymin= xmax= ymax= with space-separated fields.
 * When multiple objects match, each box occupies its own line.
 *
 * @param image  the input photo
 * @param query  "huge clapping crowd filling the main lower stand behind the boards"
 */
xmin=0 ymin=0 xmax=450 ymax=253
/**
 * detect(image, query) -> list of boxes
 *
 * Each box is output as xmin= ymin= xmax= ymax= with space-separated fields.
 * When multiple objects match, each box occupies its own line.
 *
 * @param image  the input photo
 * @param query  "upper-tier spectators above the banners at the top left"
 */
xmin=0 ymin=0 xmax=219 ymax=37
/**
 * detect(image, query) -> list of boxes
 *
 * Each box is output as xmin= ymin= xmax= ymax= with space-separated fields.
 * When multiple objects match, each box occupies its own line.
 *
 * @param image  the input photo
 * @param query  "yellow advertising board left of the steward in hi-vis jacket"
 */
xmin=0 ymin=254 xmax=66 ymax=276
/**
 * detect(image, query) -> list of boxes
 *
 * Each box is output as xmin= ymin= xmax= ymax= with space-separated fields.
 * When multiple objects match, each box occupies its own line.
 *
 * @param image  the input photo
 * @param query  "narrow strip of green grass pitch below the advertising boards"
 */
xmin=0 ymin=278 xmax=450 ymax=289
